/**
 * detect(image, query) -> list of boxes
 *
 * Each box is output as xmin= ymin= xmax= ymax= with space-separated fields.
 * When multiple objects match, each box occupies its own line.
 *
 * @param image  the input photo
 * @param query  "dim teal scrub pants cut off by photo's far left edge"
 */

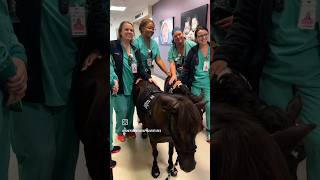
xmin=0 ymin=91 xmax=10 ymax=180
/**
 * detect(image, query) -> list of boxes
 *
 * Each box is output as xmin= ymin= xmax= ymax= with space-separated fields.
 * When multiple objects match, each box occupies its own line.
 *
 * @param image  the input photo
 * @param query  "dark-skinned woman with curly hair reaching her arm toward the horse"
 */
xmin=134 ymin=19 xmax=177 ymax=84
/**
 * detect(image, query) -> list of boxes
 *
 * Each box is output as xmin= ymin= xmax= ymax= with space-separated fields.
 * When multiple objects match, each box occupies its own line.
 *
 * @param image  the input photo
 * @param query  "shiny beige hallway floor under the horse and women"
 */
xmin=9 ymin=76 xmax=307 ymax=180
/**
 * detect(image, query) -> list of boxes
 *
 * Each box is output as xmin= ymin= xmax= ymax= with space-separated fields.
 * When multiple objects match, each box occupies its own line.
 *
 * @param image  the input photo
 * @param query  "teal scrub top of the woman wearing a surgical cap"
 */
xmin=168 ymin=40 xmax=197 ymax=65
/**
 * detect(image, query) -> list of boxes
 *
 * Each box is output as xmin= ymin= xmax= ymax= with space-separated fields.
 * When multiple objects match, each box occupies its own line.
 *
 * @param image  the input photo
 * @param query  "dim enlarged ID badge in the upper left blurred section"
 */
xmin=69 ymin=6 xmax=87 ymax=37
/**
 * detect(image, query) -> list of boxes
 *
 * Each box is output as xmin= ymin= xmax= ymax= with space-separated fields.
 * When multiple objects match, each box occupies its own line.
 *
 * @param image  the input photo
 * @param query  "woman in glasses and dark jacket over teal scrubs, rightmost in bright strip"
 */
xmin=180 ymin=26 xmax=210 ymax=142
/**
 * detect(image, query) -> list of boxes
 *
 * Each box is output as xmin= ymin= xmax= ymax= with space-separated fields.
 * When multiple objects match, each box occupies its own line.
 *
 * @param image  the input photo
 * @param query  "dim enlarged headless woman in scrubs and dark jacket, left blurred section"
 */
xmin=11 ymin=0 xmax=86 ymax=180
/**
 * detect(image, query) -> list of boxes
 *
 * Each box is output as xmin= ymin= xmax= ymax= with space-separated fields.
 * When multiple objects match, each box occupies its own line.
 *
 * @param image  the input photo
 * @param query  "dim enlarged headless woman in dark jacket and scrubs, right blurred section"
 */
xmin=213 ymin=0 xmax=320 ymax=180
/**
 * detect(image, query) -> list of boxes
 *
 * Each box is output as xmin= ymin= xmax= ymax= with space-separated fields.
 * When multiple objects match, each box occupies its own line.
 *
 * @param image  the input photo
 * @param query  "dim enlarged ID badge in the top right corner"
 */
xmin=298 ymin=0 xmax=317 ymax=30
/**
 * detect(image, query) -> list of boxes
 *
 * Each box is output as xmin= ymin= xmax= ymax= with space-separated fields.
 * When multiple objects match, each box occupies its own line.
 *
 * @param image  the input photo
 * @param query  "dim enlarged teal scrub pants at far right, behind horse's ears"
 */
xmin=260 ymin=74 xmax=320 ymax=180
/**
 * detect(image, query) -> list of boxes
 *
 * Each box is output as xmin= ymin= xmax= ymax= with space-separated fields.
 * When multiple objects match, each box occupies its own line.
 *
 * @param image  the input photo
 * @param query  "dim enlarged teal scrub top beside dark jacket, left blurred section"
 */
xmin=40 ymin=0 xmax=85 ymax=106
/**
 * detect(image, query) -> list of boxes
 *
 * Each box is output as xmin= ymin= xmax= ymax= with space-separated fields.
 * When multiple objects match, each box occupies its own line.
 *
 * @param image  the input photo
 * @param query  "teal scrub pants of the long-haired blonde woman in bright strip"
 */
xmin=112 ymin=95 xmax=134 ymax=134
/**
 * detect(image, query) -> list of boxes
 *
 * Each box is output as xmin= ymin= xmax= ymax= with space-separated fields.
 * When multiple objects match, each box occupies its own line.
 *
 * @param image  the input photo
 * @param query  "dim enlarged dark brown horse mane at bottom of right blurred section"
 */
xmin=212 ymin=113 xmax=291 ymax=180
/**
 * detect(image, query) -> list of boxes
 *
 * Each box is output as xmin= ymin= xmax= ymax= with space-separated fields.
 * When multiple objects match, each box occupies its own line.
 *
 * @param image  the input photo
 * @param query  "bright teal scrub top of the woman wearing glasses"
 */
xmin=192 ymin=47 xmax=210 ymax=88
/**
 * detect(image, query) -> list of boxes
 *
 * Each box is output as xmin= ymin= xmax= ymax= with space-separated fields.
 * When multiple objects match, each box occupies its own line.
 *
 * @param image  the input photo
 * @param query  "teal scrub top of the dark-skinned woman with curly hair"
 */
xmin=133 ymin=35 xmax=160 ymax=70
